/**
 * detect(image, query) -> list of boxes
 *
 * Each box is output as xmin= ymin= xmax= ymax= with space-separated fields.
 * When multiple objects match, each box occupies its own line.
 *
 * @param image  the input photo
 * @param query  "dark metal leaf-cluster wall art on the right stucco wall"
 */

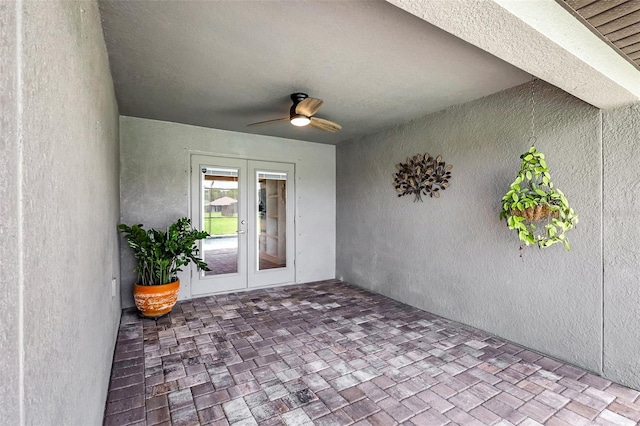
xmin=393 ymin=153 xmax=453 ymax=201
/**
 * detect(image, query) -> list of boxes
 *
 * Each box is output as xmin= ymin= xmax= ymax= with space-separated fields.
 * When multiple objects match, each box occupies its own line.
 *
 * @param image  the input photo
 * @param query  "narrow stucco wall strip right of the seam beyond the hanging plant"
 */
xmin=602 ymin=104 xmax=640 ymax=389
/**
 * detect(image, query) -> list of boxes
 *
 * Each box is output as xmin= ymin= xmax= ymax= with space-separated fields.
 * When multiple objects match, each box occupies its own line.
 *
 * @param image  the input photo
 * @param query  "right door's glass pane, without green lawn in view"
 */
xmin=256 ymin=171 xmax=287 ymax=271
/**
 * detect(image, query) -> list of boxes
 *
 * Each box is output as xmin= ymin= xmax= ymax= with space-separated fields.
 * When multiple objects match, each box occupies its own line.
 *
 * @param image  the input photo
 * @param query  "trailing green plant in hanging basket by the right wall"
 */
xmin=500 ymin=146 xmax=578 ymax=250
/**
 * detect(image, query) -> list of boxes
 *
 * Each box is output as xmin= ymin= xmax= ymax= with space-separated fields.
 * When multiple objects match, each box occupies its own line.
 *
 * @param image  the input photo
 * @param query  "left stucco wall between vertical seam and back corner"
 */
xmin=16 ymin=1 xmax=120 ymax=425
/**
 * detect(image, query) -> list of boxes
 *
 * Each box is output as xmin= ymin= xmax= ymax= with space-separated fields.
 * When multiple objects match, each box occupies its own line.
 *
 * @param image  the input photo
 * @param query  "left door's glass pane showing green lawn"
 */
xmin=201 ymin=168 xmax=240 ymax=276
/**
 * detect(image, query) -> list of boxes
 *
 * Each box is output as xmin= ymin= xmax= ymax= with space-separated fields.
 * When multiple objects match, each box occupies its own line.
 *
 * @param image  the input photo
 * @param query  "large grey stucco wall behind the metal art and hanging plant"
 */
xmin=336 ymin=83 xmax=602 ymax=372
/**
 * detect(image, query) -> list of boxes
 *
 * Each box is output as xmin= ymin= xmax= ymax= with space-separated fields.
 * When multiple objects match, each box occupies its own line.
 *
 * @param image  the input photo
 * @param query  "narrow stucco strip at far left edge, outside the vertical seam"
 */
xmin=0 ymin=2 xmax=20 ymax=425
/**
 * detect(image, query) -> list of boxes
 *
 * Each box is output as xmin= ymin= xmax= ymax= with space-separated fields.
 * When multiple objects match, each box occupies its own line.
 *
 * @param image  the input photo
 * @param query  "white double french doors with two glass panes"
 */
xmin=191 ymin=155 xmax=295 ymax=296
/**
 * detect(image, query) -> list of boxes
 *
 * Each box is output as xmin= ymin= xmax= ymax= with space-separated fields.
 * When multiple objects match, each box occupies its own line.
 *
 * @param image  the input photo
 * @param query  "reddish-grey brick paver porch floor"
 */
xmin=105 ymin=281 xmax=640 ymax=426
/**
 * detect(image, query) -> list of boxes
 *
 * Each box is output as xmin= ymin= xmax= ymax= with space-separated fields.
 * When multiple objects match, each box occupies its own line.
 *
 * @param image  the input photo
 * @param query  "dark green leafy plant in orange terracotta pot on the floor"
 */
xmin=118 ymin=217 xmax=209 ymax=317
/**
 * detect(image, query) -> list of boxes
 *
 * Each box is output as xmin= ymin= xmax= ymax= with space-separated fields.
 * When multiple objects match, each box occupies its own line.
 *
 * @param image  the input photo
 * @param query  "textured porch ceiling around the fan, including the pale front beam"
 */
xmin=100 ymin=0 xmax=640 ymax=144
